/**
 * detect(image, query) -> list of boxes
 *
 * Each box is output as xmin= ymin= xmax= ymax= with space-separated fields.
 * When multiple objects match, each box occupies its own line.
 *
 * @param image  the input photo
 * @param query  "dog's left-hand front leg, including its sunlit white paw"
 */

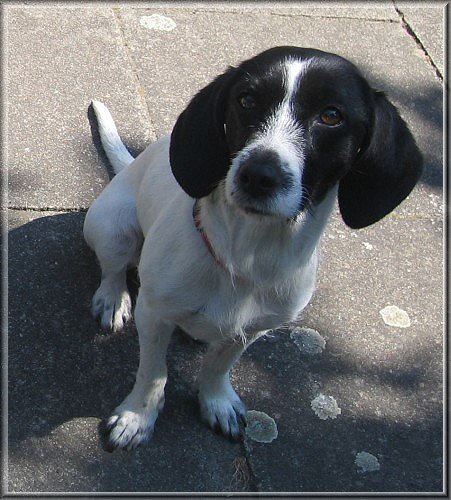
xmin=101 ymin=293 xmax=174 ymax=451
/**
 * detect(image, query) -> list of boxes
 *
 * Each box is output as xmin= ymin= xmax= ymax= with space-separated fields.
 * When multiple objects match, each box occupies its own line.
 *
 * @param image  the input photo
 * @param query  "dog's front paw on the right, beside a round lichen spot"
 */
xmin=199 ymin=384 xmax=246 ymax=441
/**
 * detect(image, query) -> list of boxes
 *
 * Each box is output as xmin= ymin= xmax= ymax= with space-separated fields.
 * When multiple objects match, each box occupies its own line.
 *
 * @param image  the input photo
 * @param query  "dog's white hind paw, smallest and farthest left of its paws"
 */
xmin=91 ymin=283 xmax=132 ymax=332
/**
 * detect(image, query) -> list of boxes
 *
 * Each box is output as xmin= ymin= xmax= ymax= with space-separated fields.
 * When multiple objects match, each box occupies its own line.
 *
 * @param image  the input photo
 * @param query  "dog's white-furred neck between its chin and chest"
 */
xmin=197 ymin=185 xmax=337 ymax=287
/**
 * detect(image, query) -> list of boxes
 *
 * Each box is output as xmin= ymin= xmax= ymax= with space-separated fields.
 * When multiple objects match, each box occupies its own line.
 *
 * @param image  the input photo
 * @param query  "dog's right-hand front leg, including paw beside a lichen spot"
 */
xmin=199 ymin=335 xmax=258 ymax=441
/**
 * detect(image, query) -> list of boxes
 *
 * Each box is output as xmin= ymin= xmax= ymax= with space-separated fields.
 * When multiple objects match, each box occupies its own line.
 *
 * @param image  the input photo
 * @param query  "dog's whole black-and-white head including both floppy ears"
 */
xmin=170 ymin=47 xmax=422 ymax=228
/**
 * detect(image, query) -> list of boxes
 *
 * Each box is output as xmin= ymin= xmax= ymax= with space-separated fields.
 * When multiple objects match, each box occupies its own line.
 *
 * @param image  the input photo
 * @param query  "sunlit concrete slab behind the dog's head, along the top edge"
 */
xmin=119 ymin=6 xmax=443 ymax=206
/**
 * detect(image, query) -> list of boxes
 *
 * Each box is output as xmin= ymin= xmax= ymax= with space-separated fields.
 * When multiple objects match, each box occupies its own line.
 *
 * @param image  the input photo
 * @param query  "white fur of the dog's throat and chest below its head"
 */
xmin=139 ymin=172 xmax=335 ymax=341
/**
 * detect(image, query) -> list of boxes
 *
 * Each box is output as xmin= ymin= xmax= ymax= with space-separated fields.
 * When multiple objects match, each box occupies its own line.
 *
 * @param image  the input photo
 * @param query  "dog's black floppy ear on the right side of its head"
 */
xmin=338 ymin=92 xmax=423 ymax=229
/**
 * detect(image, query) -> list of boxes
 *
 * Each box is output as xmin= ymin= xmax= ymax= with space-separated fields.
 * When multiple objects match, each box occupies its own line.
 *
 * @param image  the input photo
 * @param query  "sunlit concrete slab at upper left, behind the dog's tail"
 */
xmin=4 ymin=5 xmax=154 ymax=208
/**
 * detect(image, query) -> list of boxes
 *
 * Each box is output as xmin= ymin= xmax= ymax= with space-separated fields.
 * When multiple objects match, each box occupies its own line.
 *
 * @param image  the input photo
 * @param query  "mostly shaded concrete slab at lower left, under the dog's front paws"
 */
xmin=8 ymin=213 xmax=252 ymax=491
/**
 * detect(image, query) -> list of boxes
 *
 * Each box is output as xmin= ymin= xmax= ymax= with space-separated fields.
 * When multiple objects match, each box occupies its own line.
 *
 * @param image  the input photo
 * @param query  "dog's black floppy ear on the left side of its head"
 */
xmin=169 ymin=68 xmax=236 ymax=198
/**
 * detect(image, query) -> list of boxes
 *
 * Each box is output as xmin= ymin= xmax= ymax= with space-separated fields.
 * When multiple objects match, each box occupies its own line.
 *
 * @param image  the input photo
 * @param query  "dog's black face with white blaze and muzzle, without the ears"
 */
xmin=225 ymin=50 xmax=372 ymax=218
